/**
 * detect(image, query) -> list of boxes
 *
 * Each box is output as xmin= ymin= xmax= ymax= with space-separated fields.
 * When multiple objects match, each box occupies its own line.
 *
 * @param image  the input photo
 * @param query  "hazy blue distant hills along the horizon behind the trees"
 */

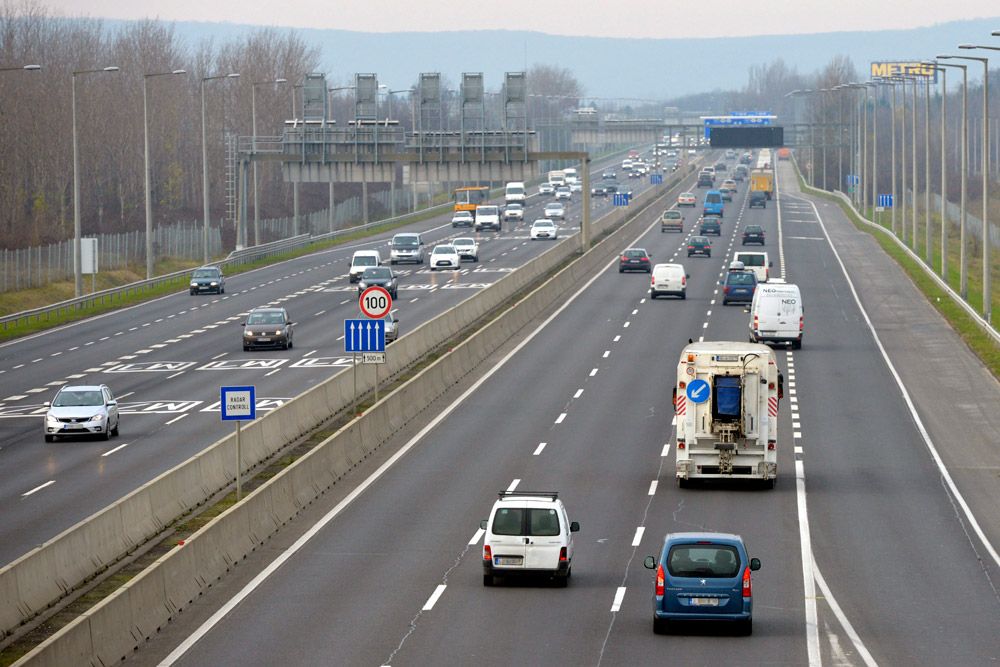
xmin=108 ymin=18 xmax=1000 ymax=98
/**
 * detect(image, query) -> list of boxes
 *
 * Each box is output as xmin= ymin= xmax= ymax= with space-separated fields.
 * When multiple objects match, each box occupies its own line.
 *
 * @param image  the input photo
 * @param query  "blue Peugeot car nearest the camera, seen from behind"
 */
xmin=643 ymin=533 xmax=760 ymax=635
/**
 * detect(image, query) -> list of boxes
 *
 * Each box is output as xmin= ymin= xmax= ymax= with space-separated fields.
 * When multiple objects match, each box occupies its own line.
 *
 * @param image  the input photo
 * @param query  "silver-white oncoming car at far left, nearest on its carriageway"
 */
xmin=42 ymin=384 xmax=121 ymax=442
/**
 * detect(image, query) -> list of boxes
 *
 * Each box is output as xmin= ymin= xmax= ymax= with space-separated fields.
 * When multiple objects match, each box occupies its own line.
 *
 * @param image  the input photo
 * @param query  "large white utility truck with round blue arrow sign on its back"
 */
xmin=673 ymin=341 xmax=784 ymax=488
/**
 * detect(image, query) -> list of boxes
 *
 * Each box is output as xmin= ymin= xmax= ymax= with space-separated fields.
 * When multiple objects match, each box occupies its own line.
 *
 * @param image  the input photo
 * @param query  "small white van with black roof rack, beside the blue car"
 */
xmin=479 ymin=491 xmax=580 ymax=586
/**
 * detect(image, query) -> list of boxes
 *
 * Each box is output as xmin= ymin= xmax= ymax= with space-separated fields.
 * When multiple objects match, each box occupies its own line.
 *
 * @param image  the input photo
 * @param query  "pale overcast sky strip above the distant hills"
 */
xmin=41 ymin=0 xmax=1000 ymax=38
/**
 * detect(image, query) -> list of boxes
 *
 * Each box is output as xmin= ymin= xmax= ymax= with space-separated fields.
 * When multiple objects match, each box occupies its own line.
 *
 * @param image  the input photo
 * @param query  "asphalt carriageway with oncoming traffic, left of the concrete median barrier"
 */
xmin=0 ymin=150 xmax=672 ymax=563
